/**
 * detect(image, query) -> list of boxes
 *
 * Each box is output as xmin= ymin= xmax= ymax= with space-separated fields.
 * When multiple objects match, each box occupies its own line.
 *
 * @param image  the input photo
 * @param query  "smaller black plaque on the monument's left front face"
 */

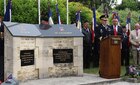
xmin=20 ymin=50 xmax=34 ymax=66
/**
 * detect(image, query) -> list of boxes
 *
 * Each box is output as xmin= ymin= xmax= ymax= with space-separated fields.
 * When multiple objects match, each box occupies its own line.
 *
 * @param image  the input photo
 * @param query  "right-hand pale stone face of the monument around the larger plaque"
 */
xmin=37 ymin=37 xmax=83 ymax=78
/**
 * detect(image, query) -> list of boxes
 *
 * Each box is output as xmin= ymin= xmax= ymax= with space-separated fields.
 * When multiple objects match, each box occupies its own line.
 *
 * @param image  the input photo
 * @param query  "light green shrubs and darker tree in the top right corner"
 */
xmin=110 ymin=0 xmax=140 ymax=29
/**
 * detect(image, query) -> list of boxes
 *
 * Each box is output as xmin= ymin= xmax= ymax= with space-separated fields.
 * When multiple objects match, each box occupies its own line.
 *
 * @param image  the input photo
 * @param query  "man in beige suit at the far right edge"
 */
xmin=130 ymin=23 xmax=140 ymax=65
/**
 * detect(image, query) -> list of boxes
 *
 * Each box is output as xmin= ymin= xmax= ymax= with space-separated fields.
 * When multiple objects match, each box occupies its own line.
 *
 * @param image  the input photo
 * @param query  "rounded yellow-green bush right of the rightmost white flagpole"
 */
xmin=69 ymin=2 xmax=100 ymax=23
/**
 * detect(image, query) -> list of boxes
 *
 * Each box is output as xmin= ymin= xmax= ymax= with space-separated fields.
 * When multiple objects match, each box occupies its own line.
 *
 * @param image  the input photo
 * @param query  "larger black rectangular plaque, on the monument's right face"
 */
xmin=53 ymin=49 xmax=73 ymax=63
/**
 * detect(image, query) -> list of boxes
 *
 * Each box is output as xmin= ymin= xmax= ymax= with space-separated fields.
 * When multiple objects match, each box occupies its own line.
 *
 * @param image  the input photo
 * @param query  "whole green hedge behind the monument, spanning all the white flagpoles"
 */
xmin=0 ymin=0 xmax=100 ymax=24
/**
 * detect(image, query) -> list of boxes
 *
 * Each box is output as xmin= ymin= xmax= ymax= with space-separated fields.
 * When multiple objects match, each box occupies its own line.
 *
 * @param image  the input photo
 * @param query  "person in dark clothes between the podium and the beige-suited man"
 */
xmin=121 ymin=26 xmax=130 ymax=67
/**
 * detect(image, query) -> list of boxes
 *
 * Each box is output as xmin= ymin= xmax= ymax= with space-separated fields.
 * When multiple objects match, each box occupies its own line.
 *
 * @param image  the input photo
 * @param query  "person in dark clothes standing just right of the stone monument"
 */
xmin=82 ymin=21 xmax=92 ymax=68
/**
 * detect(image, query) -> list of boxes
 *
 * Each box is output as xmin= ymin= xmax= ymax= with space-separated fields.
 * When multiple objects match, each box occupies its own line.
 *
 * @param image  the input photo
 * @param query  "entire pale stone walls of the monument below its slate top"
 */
xmin=5 ymin=30 xmax=83 ymax=81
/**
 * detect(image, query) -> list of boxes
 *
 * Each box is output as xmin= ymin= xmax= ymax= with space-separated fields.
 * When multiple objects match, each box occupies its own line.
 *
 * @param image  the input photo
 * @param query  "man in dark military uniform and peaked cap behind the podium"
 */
xmin=93 ymin=15 xmax=111 ymax=67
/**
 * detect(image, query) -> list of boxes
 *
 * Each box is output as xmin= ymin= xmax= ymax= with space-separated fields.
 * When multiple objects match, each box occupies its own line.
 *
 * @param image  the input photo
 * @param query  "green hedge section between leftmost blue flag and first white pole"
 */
xmin=12 ymin=0 xmax=38 ymax=23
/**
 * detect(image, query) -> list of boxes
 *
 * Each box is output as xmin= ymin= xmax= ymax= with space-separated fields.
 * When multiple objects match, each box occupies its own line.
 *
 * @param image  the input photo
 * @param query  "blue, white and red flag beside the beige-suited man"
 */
xmin=126 ymin=12 xmax=131 ymax=46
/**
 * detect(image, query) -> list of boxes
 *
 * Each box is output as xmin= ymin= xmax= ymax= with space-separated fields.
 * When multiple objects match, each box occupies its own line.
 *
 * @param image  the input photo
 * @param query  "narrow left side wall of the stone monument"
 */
xmin=4 ymin=29 xmax=14 ymax=78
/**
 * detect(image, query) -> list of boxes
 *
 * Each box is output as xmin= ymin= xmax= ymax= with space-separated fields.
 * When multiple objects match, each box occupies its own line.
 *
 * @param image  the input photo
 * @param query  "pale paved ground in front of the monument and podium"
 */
xmin=20 ymin=74 xmax=140 ymax=85
